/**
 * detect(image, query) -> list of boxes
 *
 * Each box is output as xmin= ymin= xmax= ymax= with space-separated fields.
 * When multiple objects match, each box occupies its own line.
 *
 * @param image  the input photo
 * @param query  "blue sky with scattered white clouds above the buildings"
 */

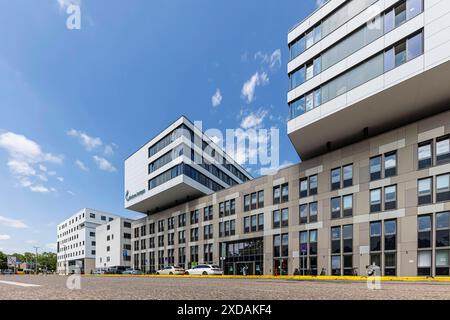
xmin=0 ymin=0 xmax=317 ymax=252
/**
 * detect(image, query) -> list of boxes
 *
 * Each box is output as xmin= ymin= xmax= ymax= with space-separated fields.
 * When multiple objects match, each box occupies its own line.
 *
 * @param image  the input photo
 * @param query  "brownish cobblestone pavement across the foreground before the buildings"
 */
xmin=0 ymin=276 xmax=450 ymax=300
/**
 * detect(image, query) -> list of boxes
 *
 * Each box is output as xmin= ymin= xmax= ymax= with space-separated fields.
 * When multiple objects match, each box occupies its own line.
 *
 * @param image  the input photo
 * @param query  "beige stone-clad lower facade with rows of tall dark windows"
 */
xmin=132 ymin=111 xmax=450 ymax=276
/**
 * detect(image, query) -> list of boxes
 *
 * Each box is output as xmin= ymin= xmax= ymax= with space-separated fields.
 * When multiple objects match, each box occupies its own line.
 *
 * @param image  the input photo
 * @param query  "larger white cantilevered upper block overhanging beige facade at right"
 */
xmin=287 ymin=0 xmax=450 ymax=160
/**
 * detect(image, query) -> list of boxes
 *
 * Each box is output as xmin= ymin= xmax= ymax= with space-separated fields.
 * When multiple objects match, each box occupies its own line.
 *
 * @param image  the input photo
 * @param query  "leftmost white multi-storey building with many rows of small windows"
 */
xmin=56 ymin=208 xmax=118 ymax=274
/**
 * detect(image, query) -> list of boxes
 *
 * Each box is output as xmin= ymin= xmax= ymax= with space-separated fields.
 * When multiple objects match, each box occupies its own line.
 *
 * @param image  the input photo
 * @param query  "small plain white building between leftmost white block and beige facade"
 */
xmin=95 ymin=217 xmax=132 ymax=270
